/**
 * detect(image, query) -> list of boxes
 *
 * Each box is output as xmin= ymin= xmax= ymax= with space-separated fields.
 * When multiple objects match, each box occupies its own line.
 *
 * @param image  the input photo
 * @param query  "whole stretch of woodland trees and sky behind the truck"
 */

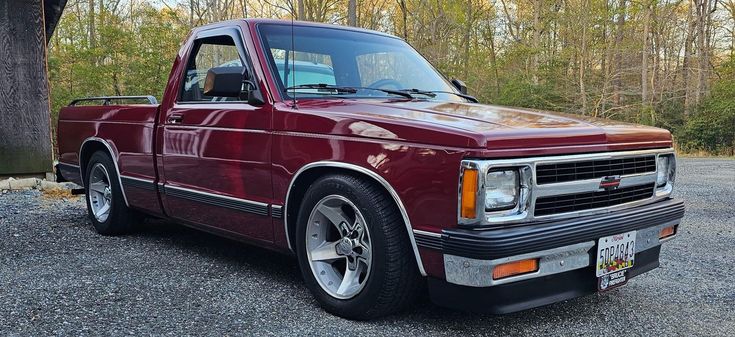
xmin=48 ymin=0 xmax=735 ymax=156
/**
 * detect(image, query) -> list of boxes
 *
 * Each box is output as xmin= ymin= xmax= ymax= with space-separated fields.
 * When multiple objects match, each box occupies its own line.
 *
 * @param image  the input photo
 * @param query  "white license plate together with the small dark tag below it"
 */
xmin=595 ymin=231 xmax=636 ymax=290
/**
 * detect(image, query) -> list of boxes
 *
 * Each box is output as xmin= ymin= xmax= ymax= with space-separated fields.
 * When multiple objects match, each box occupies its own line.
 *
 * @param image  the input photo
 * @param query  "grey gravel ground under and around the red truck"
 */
xmin=0 ymin=158 xmax=735 ymax=336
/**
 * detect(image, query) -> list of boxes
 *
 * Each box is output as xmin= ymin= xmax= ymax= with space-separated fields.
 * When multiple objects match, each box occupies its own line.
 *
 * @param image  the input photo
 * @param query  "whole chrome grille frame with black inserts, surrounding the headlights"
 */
xmin=458 ymin=149 xmax=673 ymax=226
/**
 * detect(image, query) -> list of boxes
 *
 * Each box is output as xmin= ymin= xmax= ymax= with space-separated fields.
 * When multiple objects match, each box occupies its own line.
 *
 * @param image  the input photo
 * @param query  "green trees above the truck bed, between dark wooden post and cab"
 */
xmin=48 ymin=3 xmax=189 ymax=121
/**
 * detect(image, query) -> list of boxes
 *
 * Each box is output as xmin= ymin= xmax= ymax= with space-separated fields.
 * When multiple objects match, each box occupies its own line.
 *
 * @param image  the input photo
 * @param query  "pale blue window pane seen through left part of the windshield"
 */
xmin=271 ymin=48 xmax=337 ymax=87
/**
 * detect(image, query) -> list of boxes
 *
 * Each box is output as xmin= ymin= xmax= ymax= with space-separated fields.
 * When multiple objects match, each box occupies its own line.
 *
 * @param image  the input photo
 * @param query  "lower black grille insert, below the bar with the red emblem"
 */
xmin=534 ymin=183 xmax=655 ymax=216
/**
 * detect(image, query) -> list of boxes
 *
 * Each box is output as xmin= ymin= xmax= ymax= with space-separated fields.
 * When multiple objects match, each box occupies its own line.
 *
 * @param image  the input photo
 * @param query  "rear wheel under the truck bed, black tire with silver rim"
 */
xmin=84 ymin=151 xmax=140 ymax=235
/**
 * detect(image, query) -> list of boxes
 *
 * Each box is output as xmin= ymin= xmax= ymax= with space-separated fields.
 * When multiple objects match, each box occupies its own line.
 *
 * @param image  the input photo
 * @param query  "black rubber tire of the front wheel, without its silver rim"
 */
xmin=295 ymin=174 xmax=424 ymax=320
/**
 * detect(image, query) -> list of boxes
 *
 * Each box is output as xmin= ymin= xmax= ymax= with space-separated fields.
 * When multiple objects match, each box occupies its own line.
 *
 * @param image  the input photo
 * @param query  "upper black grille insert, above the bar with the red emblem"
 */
xmin=536 ymin=155 xmax=656 ymax=185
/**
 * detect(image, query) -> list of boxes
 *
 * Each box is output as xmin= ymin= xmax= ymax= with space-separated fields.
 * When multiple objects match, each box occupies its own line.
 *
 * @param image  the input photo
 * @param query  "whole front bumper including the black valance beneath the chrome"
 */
xmin=415 ymin=199 xmax=684 ymax=313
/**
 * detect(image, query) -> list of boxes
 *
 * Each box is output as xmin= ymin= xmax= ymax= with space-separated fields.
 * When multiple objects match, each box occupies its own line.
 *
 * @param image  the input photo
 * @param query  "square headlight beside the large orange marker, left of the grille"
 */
xmin=485 ymin=170 xmax=520 ymax=211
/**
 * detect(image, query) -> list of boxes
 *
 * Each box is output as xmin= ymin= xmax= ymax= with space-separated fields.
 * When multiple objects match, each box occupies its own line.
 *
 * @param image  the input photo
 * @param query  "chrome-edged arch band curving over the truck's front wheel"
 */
xmin=284 ymin=162 xmax=426 ymax=276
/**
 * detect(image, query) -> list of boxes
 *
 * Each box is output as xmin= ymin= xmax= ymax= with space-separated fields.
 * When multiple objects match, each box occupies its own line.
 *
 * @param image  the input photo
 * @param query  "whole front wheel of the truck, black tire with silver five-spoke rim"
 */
xmin=296 ymin=175 xmax=422 ymax=320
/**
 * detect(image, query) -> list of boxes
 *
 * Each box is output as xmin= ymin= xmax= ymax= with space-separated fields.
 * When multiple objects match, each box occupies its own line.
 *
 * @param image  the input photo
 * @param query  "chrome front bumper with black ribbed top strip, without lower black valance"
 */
xmin=414 ymin=199 xmax=684 ymax=287
